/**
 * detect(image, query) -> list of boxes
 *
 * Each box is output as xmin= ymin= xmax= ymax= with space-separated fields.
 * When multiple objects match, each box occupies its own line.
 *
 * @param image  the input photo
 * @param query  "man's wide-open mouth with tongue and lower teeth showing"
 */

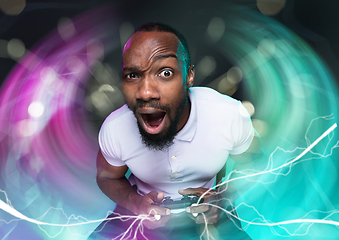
xmin=140 ymin=111 xmax=166 ymax=134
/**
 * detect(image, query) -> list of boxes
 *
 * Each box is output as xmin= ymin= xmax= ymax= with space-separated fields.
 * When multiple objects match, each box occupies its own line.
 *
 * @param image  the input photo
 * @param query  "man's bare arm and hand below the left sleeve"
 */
xmin=97 ymin=150 xmax=169 ymax=218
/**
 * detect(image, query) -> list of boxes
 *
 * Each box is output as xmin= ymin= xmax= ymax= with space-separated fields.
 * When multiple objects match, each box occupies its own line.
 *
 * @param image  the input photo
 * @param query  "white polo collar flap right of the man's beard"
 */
xmin=174 ymin=89 xmax=197 ymax=142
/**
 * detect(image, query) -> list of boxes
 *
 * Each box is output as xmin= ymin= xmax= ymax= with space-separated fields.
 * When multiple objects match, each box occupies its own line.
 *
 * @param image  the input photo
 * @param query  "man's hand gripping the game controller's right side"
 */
xmin=179 ymin=187 xmax=223 ymax=224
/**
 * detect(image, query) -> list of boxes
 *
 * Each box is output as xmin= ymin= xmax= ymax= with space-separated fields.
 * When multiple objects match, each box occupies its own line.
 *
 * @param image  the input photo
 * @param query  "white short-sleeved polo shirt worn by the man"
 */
xmin=99 ymin=87 xmax=253 ymax=199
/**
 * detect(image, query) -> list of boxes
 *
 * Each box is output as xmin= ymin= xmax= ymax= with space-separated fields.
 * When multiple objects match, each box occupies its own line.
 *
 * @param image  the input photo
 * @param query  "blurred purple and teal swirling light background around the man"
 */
xmin=0 ymin=0 xmax=339 ymax=240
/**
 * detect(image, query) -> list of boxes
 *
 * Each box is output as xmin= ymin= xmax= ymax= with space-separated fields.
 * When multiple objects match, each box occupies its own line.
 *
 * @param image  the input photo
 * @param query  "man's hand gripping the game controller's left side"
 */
xmin=134 ymin=191 xmax=171 ymax=229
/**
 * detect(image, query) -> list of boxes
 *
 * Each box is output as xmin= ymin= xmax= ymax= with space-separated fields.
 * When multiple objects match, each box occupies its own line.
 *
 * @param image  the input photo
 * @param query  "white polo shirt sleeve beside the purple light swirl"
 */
xmin=98 ymin=122 xmax=126 ymax=167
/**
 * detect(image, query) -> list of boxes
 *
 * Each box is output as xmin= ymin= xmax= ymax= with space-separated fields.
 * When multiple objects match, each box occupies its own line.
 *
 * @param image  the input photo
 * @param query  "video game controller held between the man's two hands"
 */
xmin=152 ymin=195 xmax=204 ymax=210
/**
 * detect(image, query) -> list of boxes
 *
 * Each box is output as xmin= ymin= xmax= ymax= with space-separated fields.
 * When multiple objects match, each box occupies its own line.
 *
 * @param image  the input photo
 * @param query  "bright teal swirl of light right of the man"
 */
xmin=212 ymin=7 xmax=339 ymax=239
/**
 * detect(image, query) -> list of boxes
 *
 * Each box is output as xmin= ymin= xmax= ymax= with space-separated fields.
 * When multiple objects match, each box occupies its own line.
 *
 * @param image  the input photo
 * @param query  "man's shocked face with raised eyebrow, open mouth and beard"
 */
xmin=122 ymin=32 xmax=194 ymax=150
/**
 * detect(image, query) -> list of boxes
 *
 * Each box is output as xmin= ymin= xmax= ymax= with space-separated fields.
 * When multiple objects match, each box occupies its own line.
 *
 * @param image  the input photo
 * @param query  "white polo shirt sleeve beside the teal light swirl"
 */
xmin=230 ymin=102 xmax=254 ymax=155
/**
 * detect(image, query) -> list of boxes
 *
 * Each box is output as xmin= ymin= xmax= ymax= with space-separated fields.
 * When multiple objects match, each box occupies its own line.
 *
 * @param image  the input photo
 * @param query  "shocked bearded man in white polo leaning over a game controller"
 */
xmin=91 ymin=23 xmax=253 ymax=239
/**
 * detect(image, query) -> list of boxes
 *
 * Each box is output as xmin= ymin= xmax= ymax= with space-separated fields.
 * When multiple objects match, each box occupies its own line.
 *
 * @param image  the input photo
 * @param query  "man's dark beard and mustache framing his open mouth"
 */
xmin=128 ymin=91 xmax=188 ymax=151
